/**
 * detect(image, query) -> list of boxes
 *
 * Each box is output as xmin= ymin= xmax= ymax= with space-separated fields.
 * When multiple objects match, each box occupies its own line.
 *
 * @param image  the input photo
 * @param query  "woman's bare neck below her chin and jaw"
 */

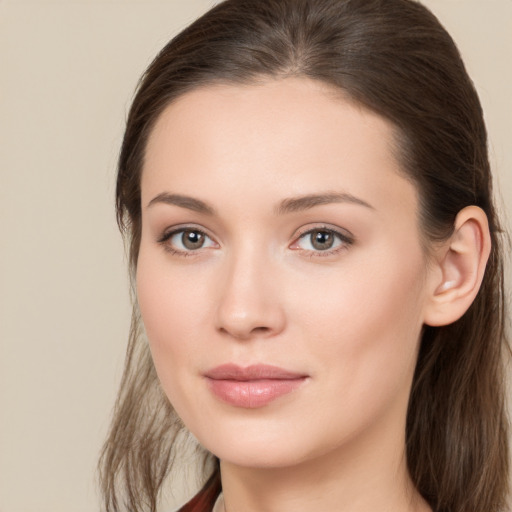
xmin=221 ymin=404 xmax=430 ymax=512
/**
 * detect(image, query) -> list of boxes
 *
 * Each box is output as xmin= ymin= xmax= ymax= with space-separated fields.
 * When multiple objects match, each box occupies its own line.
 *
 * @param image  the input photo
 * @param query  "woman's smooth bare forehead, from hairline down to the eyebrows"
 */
xmin=142 ymin=78 xmax=415 ymax=218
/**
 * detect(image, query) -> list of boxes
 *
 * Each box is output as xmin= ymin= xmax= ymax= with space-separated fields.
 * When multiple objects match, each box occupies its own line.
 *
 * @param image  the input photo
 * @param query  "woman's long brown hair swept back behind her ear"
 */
xmin=100 ymin=0 xmax=508 ymax=512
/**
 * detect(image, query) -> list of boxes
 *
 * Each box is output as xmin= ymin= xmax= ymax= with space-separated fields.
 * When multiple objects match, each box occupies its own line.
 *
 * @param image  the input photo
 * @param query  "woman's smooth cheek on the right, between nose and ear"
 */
xmin=294 ymin=246 xmax=425 ymax=401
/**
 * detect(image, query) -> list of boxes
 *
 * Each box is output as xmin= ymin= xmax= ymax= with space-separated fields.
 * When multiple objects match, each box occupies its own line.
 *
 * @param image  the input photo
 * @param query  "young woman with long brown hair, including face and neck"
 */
xmin=102 ymin=0 xmax=508 ymax=512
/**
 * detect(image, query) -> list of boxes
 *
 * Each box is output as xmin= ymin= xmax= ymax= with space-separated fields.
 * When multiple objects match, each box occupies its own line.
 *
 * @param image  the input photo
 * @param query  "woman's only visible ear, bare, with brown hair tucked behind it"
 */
xmin=424 ymin=206 xmax=491 ymax=326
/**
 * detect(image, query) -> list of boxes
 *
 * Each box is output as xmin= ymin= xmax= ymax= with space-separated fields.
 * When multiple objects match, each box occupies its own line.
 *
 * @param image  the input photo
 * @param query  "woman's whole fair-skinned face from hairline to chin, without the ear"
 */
xmin=137 ymin=78 xmax=428 ymax=467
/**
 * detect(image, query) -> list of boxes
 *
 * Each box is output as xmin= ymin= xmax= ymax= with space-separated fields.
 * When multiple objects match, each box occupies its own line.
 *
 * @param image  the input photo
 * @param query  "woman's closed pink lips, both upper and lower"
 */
xmin=204 ymin=364 xmax=308 ymax=409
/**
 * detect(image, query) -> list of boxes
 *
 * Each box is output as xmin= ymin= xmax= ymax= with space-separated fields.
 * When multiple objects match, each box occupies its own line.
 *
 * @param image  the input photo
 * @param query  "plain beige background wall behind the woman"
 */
xmin=0 ymin=0 xmax=512 ymax=512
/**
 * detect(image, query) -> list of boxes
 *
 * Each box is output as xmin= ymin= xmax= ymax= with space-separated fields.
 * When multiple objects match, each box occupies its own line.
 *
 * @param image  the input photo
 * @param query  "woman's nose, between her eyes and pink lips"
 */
xmin=216 ymin=251 xmax=286 ymax=340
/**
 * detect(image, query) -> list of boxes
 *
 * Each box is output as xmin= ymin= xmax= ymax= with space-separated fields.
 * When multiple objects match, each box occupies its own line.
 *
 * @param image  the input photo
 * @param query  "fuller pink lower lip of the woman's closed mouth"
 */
xmin=208 ymin=377 xmax=306 ymax=409
